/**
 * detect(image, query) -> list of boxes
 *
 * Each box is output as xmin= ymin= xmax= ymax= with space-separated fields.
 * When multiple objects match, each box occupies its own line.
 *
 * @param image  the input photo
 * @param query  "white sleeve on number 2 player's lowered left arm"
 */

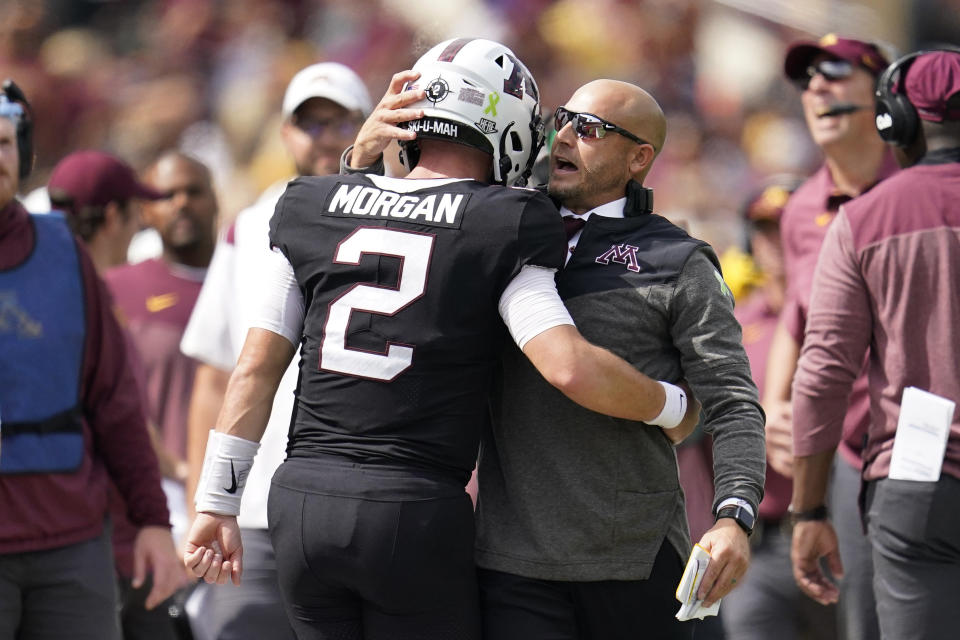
xmin=250 ymin=249 xmax=304 ymax=347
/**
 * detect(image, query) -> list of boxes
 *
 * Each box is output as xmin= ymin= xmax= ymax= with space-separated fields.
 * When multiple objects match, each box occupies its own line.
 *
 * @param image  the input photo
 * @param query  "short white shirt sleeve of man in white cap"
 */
xmin=180 ymin=240 xmax=240 ymax=371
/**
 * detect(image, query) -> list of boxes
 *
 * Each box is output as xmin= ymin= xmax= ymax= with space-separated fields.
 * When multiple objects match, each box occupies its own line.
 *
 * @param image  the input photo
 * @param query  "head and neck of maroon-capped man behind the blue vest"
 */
xmin=47 ymin=151 xmax=163 ymax=273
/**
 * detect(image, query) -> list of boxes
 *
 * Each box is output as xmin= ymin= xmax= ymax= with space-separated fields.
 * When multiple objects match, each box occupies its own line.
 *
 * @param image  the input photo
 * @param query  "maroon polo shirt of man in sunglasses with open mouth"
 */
xmin=780 ymin=153 xmax=897 ymax=469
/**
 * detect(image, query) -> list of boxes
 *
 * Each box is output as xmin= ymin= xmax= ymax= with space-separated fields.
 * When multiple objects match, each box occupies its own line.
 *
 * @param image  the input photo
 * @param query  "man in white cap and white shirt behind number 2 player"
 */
xmin=180 ymin=62 xmax=372 ymax=640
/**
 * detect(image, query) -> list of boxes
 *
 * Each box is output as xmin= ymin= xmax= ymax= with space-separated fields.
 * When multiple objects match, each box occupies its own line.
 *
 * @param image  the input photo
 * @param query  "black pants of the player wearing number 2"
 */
xmin=268 ymin=456 xmax=480 ymax=640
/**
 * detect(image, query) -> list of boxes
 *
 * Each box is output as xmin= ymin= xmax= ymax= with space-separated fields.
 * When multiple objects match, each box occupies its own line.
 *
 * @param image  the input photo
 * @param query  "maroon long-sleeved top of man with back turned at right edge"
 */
xmin=793 ymin=155 xmax=960 ymax=479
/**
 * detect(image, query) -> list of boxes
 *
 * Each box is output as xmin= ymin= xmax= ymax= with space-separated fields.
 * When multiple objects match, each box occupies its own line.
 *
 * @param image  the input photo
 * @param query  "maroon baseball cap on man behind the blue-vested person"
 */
xmin=47 ymin=151 xmax=166 ymax=213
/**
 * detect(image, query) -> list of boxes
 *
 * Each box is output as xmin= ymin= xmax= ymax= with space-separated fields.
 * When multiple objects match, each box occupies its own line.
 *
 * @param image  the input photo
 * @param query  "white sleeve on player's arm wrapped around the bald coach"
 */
xmin=499 ymin=265 xmax=573 ymax=349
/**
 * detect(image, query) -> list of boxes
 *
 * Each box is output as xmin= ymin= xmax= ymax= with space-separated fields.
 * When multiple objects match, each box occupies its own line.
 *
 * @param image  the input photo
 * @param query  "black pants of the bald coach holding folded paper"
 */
xmin=477 ymin=542 xmax=696 ymax=640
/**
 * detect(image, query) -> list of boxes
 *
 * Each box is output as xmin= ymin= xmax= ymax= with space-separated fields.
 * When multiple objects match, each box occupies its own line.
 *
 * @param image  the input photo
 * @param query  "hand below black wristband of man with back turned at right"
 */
xmin=790 ymin=520 xmax=843 ymax=604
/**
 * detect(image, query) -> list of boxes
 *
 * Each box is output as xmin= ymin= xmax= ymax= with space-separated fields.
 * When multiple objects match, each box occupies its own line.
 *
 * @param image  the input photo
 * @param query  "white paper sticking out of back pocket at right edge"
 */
xmin=888 ymin=387 xmax=956 ymax=482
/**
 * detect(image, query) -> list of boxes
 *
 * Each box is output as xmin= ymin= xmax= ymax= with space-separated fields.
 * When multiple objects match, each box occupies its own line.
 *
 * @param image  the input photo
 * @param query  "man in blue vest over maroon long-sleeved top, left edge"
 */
xmin=0 ymin=84 xmax=182 ymax=640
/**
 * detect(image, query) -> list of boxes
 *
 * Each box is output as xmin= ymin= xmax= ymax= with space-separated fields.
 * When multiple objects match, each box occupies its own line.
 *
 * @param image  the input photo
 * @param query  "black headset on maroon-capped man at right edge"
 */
xmin=876 ymin=45 xmax=960 ymax=147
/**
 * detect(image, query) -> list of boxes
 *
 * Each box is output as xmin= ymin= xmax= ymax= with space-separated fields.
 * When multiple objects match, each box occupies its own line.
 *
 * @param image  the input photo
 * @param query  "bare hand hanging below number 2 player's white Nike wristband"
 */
xmin=183 ymin=512 xmax=243 ymax=584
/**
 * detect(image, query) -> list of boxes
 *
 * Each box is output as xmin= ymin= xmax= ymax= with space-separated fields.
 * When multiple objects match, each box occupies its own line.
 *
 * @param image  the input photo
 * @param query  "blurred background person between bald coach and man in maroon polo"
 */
xmin=721 ymin=176 xmax=837 ymax=640
